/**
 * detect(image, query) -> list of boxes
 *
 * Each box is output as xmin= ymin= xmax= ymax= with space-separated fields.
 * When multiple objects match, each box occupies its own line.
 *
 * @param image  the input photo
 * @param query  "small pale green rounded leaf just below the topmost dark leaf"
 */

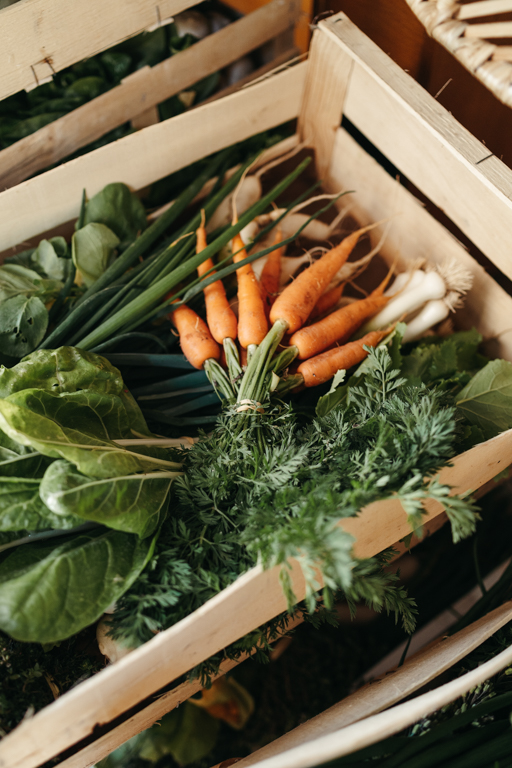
xmin=71 ymin=223 xmax=119 ymax=288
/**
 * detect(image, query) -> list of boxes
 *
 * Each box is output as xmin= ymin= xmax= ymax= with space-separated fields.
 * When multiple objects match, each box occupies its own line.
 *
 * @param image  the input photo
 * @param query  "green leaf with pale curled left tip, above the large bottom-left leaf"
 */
xmin=39 ymin=461 xmax=176 ymax=538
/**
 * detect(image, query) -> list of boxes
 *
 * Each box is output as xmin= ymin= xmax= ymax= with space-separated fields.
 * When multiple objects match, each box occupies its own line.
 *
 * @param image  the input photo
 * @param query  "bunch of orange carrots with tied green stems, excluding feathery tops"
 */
xmin=169 ymin=206 xmax=392 ymax=411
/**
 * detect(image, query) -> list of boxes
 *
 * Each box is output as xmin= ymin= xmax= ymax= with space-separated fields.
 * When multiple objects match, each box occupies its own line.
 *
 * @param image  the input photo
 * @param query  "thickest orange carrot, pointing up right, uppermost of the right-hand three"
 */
xmin=270 ymin=224 xmax=377 ymax=333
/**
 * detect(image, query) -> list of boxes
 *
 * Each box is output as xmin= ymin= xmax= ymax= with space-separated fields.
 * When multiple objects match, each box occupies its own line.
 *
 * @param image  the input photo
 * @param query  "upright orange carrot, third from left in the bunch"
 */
xmin=233 ymin=230 xmax=268 ymax=349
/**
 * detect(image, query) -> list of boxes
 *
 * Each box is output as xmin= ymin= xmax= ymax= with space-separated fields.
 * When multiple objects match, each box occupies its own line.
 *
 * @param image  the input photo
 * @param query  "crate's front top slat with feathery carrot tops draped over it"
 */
xmin=0 ymin=430 xmax=512 ymax=768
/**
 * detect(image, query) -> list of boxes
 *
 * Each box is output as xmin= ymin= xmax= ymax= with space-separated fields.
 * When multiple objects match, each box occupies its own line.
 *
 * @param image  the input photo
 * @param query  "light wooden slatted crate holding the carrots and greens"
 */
xmin=0 ymin=14 xmax=512 ymax=768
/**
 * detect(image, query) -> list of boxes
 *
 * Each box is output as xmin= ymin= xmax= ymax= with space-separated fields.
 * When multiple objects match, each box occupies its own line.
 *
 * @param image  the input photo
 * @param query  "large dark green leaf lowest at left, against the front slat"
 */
xmin=0 ymin=530 xmax=155 ymax=643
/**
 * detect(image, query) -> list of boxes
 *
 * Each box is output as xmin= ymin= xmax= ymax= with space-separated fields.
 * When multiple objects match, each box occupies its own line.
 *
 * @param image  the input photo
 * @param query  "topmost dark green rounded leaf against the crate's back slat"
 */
xmin=85 ymin=182 xmax=147 ymax=250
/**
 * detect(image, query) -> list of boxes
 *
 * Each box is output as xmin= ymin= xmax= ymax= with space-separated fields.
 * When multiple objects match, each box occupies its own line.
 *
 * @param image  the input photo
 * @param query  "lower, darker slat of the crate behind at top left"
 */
xmin=0 ymin=0 xmax=298 ymax=190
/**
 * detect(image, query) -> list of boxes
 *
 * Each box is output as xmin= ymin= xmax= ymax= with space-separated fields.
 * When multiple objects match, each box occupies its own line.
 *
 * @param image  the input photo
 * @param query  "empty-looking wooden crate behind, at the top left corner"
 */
xmin=0 ymin=0 xmax=302 ymax=189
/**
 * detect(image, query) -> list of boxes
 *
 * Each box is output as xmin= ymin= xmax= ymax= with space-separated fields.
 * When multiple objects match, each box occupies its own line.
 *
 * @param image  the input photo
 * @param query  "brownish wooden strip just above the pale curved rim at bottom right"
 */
xmin=232 ymin=601 xmax=512 ymax=768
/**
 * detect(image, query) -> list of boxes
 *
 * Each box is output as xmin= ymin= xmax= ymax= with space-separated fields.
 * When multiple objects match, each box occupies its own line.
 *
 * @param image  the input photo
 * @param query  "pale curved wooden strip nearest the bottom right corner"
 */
xmin=239 ymin=616 xmax=512 ymax=768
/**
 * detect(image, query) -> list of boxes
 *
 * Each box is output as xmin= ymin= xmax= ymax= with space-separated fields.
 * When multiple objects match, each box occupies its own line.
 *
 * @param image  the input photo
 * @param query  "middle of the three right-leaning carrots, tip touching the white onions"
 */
xmin=290 ymin=269 xmax=392 ymax=360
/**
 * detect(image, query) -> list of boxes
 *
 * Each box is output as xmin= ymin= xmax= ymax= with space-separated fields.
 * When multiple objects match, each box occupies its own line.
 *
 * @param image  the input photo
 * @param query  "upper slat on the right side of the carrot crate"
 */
xmin=319 ymin=14 xmax=512 ymax=277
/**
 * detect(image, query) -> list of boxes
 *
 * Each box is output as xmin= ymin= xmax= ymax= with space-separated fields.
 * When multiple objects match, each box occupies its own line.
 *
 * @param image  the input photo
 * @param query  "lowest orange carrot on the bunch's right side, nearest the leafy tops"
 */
xmin=297 ymin=328 xmax=391 ymax=387
